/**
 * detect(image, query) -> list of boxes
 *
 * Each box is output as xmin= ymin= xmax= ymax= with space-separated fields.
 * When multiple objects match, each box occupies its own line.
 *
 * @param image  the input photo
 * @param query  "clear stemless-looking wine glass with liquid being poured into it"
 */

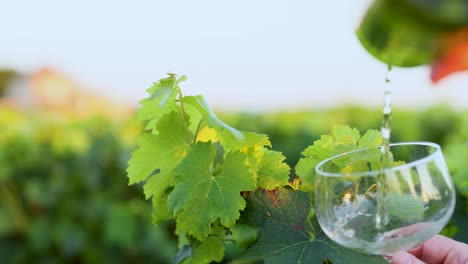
xmin=315 ymin=142 xmax=455 ymax=256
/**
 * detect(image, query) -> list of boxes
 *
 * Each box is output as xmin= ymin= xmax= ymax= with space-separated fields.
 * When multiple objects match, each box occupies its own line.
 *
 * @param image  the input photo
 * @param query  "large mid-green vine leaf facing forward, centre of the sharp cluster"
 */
xmin=168 ymin=142 xmax=256 ymax=241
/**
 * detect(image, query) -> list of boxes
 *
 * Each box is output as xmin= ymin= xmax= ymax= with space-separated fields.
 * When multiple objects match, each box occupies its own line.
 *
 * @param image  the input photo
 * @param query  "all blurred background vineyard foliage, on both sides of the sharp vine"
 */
xmin=0 ymin=106 xmax=468 ymax=263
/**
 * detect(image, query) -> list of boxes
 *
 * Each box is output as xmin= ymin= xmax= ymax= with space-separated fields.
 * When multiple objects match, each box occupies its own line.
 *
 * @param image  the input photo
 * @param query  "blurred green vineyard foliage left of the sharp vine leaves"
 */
xmin=0 ymin=109 xmax=176 ymax=263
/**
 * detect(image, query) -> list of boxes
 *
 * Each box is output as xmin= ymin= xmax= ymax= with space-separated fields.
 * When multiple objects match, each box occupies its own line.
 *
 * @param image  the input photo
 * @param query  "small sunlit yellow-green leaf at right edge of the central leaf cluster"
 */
xmin=257 ymin=149 xmax=289 ymax=190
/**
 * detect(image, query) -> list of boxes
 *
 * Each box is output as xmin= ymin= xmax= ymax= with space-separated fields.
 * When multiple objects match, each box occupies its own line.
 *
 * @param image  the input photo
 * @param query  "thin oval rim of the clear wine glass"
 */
xmin=315 ymin=141 xmax=442 ymax=177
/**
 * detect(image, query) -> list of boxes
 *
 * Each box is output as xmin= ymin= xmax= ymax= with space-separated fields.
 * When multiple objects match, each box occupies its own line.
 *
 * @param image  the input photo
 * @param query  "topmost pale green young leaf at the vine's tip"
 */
xmin=137 ymin=73 xmax=187 ymax=130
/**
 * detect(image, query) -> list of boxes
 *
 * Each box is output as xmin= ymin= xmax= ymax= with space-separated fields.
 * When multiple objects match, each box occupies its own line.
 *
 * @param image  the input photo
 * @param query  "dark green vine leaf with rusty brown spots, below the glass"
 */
xmin=233 ymin=189 xmax=387 ymax=264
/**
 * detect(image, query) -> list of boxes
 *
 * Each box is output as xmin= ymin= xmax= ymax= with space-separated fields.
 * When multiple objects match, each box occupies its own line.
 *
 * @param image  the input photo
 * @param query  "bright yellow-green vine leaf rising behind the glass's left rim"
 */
xmin=295 ymin=126 xmax=382 ymax=191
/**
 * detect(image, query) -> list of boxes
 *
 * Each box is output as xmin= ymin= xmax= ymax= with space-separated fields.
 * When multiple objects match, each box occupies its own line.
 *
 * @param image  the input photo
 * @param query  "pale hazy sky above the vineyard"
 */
xmin=0 ymin=0 xmax=468 ymax=111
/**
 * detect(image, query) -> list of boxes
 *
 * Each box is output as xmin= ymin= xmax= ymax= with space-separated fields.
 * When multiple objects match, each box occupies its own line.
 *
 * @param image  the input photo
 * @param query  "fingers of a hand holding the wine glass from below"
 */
xmin=391 ymin=235 xmax=468 ymax=264
